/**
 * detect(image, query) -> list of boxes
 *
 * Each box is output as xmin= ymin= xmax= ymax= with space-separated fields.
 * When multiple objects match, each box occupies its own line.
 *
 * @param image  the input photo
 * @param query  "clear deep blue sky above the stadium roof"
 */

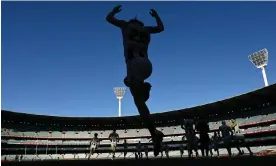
xmin=2 ymin=2 xmax=276 ymax=117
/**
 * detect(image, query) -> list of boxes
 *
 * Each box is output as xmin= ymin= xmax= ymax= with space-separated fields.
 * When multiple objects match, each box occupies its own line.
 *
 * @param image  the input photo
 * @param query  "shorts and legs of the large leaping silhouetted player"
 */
xmin=124 ymin=58 xmax=163 ymax=156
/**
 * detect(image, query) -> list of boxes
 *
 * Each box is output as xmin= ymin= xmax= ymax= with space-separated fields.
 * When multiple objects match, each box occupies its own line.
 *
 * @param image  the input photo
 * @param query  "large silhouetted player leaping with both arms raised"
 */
xmin=106 ymin=5 xmax=164 ymax=156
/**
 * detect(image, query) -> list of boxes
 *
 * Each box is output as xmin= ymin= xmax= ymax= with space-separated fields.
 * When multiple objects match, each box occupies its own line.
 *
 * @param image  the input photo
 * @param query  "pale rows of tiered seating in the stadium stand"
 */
xmin=1 ymin=110 xmax=276 ymax=160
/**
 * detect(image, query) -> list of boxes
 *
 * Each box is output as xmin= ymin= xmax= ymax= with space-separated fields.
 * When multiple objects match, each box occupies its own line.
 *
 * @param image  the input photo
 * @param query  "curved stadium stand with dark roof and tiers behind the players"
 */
xmin=1 ymin=84 xmax=276 ymax=165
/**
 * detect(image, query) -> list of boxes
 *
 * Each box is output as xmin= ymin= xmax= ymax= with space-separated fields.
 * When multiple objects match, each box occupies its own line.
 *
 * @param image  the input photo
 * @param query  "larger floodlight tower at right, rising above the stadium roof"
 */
xmin=248 ymin=48 xmax=268 ymax=86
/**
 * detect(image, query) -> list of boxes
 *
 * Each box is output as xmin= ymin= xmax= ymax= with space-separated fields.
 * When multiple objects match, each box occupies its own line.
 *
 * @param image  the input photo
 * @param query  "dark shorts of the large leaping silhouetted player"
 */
xmin=127 ymin=57 xmax=152 ymax=83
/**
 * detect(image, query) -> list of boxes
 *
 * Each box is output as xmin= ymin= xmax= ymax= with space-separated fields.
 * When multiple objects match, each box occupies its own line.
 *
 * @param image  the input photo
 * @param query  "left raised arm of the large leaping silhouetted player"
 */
xmin=106 ymin=5 xmax=127 ymax=28
